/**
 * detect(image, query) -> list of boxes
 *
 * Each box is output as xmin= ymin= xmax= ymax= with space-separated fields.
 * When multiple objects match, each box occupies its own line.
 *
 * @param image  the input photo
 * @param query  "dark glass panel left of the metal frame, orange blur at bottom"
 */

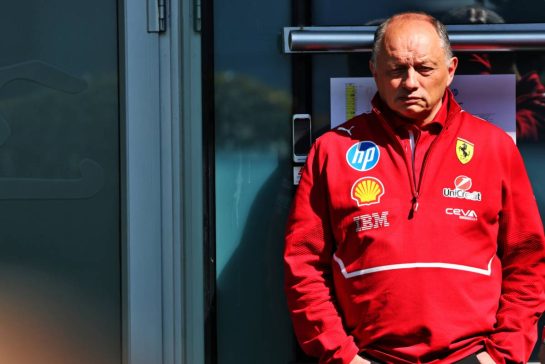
xmin=0 ymin=0 xmax=121 ymax=364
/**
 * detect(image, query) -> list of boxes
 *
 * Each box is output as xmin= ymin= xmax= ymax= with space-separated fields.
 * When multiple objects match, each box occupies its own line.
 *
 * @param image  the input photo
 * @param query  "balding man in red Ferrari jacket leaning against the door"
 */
xmin=284 ymin=13 xmax=545 ymax=364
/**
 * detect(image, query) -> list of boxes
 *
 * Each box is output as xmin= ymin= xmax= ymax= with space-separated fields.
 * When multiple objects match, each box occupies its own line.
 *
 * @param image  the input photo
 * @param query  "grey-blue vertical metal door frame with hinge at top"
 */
xmin=122 ymin=0 xmax=204 ymax=364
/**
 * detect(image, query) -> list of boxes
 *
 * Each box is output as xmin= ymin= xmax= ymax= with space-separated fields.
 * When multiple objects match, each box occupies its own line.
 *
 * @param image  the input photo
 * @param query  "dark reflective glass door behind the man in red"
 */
xmin=205 ymin=0 xmax=545 ymax=363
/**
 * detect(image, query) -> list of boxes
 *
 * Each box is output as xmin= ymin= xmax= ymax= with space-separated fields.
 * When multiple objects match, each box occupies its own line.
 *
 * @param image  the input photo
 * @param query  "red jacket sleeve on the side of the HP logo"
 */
xmin=284 ymin=145 xmax=358 ymax=364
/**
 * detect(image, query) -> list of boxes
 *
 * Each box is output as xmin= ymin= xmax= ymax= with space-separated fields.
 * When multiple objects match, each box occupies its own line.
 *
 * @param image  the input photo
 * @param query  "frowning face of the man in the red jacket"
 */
xmin=370 ymin=19 xmax=458 ymax=124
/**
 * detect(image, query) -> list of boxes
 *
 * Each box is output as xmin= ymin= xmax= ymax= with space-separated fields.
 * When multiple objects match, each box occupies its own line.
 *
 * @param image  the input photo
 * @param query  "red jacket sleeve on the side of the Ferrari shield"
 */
xmin=486 ymin=146 xmax=545 ymax=363
